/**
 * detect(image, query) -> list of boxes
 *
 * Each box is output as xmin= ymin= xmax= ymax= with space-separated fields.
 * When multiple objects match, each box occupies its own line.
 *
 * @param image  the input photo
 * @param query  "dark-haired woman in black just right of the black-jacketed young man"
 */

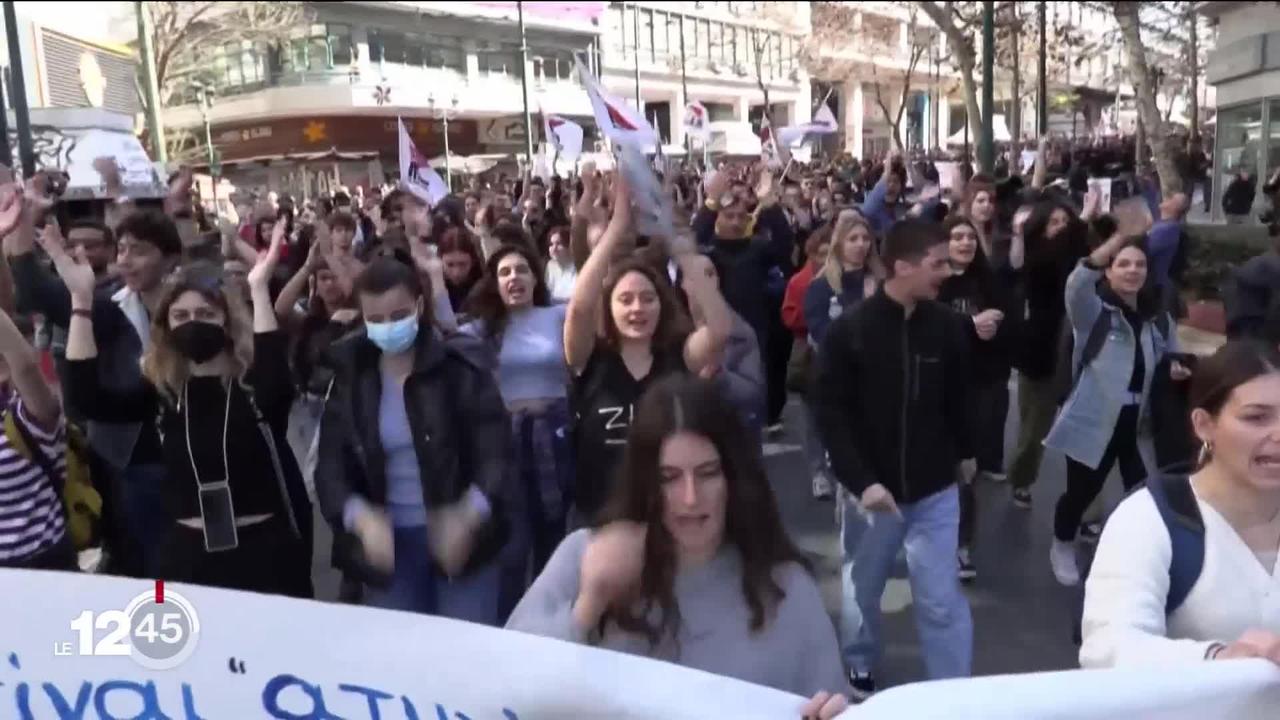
xmin=938 ymin=215 xmax=1016 ymax=582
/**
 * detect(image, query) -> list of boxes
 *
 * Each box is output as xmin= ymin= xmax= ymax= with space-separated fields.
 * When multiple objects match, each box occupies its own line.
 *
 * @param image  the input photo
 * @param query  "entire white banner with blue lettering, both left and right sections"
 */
xmin=0 ymin=569 xmax=1280 ymax=720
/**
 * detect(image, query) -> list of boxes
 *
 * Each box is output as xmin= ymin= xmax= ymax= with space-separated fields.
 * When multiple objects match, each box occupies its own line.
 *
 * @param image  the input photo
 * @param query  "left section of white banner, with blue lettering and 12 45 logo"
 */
xmin=0 ymin=570 xmax=804 ymax=720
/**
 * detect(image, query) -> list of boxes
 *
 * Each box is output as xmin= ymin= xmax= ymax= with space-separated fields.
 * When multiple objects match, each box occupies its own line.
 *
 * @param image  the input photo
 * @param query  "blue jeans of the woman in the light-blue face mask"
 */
xmin=365 ymin=525 xmax=500 ymax=625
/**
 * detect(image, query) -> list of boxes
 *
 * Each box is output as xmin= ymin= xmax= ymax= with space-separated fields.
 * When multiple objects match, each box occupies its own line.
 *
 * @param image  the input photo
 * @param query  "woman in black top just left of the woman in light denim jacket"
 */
xmin=1009 ymin=194 xmax=1097 ymax=509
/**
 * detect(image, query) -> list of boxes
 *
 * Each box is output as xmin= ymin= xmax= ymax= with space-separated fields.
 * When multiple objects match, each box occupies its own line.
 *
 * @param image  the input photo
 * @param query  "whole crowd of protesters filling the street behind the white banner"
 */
xmin=0 ymin=120 xmax=1280 ymax=717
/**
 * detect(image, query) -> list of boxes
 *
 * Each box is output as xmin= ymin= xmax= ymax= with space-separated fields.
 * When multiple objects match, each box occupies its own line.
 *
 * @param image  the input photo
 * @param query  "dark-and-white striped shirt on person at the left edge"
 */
xmin=0 ymin=395 xmax=67 ymax=565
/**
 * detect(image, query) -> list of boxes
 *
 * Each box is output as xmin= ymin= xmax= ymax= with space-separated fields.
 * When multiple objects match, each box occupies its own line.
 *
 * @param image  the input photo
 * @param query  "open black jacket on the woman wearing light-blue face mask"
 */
xmin=315 ymin=324 xmax=511 ymax=576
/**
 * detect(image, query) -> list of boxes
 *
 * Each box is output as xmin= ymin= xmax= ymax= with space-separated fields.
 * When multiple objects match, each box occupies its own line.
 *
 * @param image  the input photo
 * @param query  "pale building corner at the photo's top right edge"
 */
xmin=1199 ymin=3 xmax=1280 ymax=219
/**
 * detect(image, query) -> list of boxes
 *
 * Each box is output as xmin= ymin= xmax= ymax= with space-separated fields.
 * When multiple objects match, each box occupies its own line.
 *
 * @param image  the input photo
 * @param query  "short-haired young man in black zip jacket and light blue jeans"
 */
xmin=813 ymin=220 xmax=973 ymax=697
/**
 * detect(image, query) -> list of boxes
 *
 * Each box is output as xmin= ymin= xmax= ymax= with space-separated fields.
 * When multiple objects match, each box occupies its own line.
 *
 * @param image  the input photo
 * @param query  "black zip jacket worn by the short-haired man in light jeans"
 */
xmin=810 ymin=287 xmax=973 ymax=502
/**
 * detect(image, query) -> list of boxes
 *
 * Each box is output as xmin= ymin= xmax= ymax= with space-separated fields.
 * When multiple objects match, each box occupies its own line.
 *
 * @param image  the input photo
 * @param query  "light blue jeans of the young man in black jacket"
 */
xmin=844 ymin=486 xmax=973 ymax=680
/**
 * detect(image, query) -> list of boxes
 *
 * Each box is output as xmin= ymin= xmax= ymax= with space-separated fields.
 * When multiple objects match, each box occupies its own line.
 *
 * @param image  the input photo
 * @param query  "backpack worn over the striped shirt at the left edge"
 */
xmin=4 ymin=411 xmax=102 ymax=550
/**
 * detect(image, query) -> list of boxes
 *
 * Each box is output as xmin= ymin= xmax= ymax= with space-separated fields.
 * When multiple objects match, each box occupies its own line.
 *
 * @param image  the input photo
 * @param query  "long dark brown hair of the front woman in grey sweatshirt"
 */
xmin=602 ymin=375 xmax=809 ymax=647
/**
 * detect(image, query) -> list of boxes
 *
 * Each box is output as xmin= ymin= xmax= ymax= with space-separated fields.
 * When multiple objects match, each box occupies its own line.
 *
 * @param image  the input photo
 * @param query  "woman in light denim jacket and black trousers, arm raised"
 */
xmin=1044 ymin=222 xmax=1190 ymax=585
